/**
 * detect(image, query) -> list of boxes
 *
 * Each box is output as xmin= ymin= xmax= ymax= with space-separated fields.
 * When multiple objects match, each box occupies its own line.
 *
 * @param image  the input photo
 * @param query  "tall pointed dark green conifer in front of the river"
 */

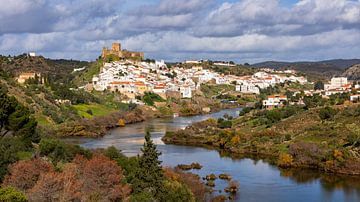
xmin=132 ymin=131 xmax=165 ymax=201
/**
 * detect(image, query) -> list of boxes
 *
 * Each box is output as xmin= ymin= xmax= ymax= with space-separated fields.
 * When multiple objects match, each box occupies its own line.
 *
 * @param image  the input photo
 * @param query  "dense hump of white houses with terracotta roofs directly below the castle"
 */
xmin=92 ymin=61 xmax=196 ymax=99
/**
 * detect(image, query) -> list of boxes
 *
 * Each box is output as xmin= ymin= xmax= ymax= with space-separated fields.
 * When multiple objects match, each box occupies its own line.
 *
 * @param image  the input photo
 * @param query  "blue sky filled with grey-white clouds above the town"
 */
xmin=0 ymin=0 xmax=360 ymax=63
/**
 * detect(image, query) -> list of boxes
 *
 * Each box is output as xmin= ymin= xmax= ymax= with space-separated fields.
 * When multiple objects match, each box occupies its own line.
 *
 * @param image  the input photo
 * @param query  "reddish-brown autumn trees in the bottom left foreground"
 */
xmin=4 ymin=155 xmax=131 ymax=201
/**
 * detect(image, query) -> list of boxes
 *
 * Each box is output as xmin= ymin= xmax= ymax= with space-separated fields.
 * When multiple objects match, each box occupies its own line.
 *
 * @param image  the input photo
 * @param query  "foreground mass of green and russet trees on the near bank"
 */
xmin=0 ymin=112 xmax=211 ymax=201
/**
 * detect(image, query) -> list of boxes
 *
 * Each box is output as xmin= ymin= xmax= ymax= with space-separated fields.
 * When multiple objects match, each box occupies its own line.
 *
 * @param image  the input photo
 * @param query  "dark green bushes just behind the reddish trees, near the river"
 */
xmin=40 ymin=139 xmax=91 ymax=163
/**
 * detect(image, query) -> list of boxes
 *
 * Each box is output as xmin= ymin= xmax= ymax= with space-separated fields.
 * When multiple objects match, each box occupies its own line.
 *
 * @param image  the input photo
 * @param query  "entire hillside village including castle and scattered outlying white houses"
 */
xmin=14 ymin=43 xmax=360 ymax=109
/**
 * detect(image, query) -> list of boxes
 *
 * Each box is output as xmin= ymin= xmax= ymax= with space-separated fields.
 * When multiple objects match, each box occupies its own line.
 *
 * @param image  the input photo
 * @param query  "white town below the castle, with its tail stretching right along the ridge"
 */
xmin=92 ymin=57 xmax=307 ymax=103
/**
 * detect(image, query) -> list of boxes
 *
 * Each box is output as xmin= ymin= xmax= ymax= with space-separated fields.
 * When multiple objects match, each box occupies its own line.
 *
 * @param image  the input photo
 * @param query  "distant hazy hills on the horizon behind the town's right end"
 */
xmin=252 ymin=59 xmax=360 ymax=77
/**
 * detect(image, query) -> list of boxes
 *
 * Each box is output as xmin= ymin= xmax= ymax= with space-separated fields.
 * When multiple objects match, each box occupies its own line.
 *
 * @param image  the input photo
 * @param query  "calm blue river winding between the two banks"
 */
xmin=72 ymin=109 xmax=360 ymax=202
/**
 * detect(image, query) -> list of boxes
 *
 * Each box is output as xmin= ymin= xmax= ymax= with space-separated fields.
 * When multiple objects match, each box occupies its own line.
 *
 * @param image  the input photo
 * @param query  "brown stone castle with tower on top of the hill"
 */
xmin=101 ymin=43 xmax=144 ymax=60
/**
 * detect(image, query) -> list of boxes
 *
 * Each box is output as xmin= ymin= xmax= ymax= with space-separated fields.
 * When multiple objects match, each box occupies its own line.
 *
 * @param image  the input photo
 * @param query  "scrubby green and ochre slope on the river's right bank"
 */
xmin=162 ymin=105 xmax=360 ymax=175
